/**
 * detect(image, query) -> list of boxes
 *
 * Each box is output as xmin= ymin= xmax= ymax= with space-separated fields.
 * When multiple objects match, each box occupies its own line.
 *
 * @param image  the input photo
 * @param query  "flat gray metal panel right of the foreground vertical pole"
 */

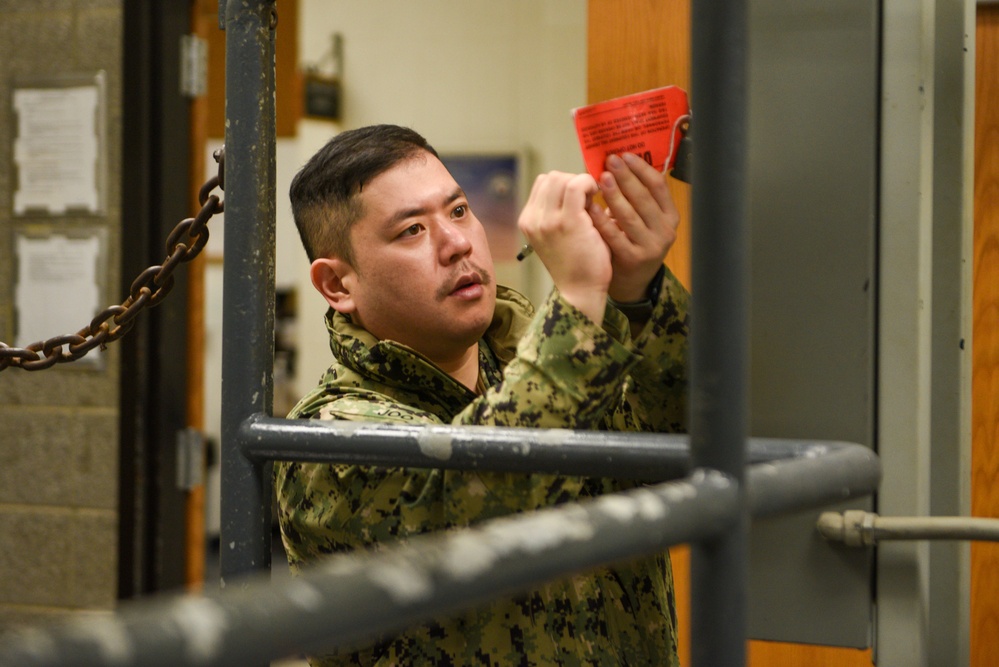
xmin=748 ymin=0 xmax=880 ymax=646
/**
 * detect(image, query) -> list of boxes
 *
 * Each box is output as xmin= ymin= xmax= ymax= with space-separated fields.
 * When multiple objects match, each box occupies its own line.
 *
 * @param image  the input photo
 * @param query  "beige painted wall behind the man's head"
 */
xmin=292 ymin=0 xmax=586 ymax=394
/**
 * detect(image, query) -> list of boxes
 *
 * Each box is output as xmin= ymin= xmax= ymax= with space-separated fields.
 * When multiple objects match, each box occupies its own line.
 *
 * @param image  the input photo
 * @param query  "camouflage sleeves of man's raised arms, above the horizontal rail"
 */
xmin=454 ymin=271 xmax=689 ymax=433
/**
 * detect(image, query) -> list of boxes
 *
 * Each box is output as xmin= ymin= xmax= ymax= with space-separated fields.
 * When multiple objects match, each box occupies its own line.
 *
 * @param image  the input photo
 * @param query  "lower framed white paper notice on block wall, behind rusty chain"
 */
xmin=14 ymin=234 xmax=103 ymax=361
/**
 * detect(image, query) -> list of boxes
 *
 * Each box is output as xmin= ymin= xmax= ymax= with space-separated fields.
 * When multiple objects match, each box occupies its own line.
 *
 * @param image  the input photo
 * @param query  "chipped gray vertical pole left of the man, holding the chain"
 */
xmin=220 ymin=0 xmax=276 ymax=586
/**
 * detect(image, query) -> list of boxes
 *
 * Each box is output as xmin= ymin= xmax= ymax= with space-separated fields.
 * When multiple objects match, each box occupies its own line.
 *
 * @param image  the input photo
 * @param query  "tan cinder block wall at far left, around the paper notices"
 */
xmin=0 ymin=0 xmax=122 ymax=634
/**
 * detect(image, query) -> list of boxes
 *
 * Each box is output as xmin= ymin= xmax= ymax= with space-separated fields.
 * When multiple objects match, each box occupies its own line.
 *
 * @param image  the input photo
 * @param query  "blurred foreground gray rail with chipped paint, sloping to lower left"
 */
xmin=0 ymin=456 xmax=878 ymax=667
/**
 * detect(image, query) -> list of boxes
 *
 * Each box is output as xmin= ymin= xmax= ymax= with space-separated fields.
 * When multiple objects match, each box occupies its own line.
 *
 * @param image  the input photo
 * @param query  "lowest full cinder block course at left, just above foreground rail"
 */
xmin=0 ymin=505 xmax=118 ymax=609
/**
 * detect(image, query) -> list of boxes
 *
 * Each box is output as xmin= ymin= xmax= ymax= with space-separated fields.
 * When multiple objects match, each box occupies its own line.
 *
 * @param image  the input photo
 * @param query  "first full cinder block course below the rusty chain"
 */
xmin=0 ymin=408 xmax=118 ymax=512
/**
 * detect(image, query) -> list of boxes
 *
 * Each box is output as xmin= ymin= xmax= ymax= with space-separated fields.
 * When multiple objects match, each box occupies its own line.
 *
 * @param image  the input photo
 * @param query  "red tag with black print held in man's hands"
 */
xmin=572 ymin=86 xmax=690 ymax=179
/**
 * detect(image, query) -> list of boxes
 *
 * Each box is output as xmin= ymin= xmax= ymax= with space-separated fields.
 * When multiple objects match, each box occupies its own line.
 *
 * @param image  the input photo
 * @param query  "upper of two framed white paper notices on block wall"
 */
xmin=13 ymin=79 xmax=102 ymax=215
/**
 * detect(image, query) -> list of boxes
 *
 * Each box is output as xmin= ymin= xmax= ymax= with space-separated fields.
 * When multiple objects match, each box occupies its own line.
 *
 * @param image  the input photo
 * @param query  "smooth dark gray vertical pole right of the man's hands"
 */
xmin=690 ymin=0 xmax=749 ymax=667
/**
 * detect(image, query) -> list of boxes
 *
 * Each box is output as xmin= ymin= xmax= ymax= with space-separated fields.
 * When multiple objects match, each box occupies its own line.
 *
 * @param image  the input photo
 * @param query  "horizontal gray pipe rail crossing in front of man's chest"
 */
xmin=239 ymin=415 xmax=880 ymax=488
